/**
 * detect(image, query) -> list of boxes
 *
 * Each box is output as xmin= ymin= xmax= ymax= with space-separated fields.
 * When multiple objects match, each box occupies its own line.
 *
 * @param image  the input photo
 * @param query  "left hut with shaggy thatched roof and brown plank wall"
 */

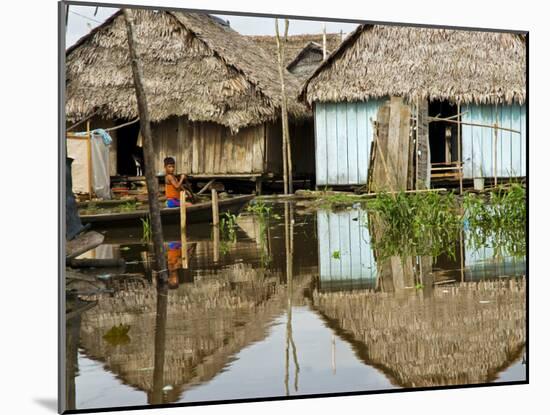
xmin=66 ymin=10 xmax=309 ymax=188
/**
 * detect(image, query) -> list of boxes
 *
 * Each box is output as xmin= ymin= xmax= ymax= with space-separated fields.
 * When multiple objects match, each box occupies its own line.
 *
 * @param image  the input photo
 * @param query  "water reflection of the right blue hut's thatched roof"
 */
xmin=314 ymin=278 xmax=526 ymax=387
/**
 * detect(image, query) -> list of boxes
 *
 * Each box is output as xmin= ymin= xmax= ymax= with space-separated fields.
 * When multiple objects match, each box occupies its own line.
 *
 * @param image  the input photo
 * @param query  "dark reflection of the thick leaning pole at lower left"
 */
xmin=149 ymin=284 xmax=168 ymax=405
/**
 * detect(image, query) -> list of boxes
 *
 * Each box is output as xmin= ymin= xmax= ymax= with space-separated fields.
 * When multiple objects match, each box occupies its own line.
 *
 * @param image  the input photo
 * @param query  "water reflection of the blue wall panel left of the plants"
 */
xmin=317 ymin=209 xmax=376 ymax=286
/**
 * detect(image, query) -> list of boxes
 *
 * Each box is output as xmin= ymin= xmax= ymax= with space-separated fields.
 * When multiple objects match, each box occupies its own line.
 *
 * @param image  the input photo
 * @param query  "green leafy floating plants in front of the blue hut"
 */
xmin=366 ymin=184 xmax=527 ymax=259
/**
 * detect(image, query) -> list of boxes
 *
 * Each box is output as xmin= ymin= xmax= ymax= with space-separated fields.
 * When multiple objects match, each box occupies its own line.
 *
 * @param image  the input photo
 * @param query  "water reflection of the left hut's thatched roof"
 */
xmin=81 ymin=266 xmax=294 ymax=401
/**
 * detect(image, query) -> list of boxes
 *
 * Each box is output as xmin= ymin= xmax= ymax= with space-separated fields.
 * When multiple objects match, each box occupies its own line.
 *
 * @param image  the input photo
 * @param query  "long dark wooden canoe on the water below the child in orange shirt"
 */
xmin=80 ymin=195 xmax=255 ymax=224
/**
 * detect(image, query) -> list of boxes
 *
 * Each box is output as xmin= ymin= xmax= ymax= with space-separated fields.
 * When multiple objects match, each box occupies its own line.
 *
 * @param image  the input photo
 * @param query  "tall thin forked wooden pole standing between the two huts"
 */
xmin=275 ymin=19 xmax=293 ymax=194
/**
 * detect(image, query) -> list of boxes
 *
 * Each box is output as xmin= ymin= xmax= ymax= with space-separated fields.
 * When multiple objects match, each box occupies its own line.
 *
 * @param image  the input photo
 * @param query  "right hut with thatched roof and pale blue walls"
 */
xmin=301 ymin=25 xmax=527 ymax=185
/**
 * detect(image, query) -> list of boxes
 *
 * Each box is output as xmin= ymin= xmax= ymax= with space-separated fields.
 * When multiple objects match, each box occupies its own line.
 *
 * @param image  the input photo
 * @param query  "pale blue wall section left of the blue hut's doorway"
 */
xmin=315 ymin=99 xmax=385 ymax=186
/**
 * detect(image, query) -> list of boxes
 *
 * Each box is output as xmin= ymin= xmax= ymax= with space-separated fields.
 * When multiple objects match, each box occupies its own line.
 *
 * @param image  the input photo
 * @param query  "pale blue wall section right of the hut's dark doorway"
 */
xmin=461 ymin=104 xmax=527 ymax=179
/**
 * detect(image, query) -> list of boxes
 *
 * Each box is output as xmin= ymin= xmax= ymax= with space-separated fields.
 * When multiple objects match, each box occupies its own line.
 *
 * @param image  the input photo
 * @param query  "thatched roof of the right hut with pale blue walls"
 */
xmin=301 ymin=25 xmax=526 ymax=104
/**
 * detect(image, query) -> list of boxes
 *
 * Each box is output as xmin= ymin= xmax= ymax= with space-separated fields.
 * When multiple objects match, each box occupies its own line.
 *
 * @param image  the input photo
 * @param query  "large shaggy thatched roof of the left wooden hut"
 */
xmin=66 ymin=10 xmax=308 ymax=131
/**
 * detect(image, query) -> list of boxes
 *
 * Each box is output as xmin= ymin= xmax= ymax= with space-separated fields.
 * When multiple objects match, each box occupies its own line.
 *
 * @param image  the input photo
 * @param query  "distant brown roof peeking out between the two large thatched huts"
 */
xmin=248 ymin=34 xmax=342 ymax=68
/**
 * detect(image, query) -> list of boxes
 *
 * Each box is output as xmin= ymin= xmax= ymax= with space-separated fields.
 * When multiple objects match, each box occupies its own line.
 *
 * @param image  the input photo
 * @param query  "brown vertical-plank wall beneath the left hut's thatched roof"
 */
xmin=153 ymin=117 xmax=265 ymax=175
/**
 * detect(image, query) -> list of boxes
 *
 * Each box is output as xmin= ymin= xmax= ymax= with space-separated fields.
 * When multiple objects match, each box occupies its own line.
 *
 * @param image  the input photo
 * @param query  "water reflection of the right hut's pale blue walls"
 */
xmin=317 ymin=208 xmax=526 ymax=291
